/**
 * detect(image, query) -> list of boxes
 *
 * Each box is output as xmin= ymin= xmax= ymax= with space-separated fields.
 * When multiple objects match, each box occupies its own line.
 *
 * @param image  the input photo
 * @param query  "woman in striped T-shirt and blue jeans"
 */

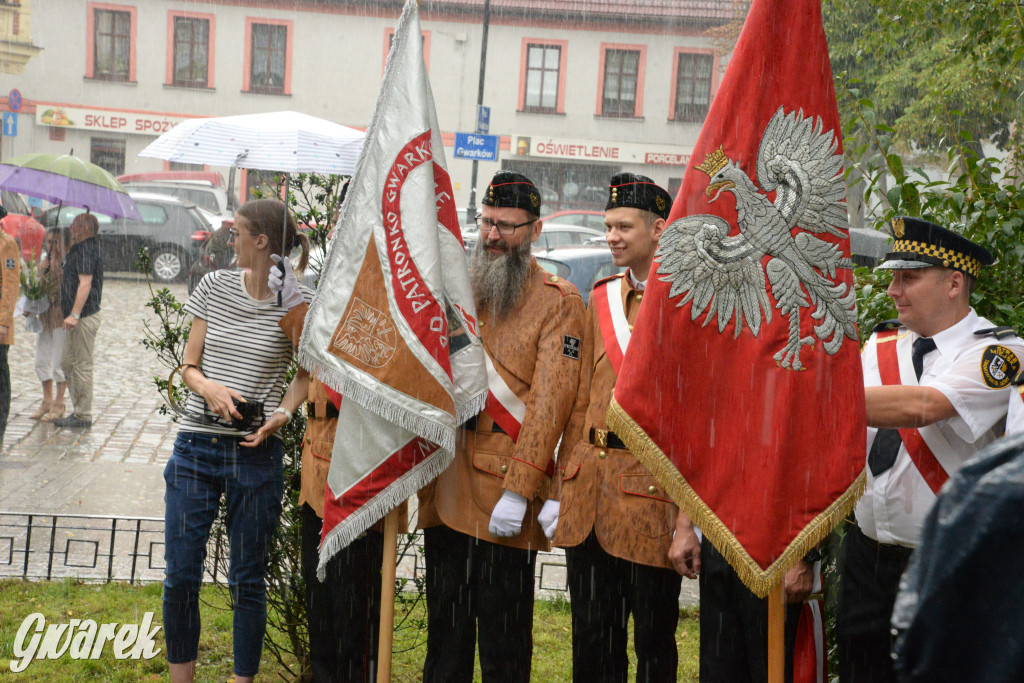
xmin=164 ymin=200 xmax=312 ymax=681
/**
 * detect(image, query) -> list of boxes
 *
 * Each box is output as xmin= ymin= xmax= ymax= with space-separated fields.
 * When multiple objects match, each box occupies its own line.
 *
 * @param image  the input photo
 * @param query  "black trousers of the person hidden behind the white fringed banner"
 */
xmin=302 ymin=505 xmax=384 ymax=683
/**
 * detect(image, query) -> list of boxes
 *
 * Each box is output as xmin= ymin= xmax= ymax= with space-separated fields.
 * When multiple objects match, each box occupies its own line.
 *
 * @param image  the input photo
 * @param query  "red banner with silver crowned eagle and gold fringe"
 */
xmin=608 ymin=0 xmax=865 ymax=596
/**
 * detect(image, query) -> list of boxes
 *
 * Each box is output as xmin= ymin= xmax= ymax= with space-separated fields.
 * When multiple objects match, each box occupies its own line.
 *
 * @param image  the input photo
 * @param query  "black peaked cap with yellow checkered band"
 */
xmin=878 ymin=216 xmax=995 ymax=278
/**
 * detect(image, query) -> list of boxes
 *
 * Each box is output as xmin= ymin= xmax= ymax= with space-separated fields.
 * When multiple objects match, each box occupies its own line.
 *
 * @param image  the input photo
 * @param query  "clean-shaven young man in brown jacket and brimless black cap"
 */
xmin=554 ymin=173 xmax=698 ymax=682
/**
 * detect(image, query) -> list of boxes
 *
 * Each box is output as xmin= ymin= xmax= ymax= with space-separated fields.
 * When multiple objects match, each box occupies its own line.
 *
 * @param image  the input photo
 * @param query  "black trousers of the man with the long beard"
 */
xmin=423 ymin=526 xmax=537 ymax=683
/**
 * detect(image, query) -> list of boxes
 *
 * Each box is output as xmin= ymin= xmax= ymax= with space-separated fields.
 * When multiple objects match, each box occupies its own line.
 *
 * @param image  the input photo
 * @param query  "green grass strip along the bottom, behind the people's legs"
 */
xmin=0 ymin=580 xmax=699 ymax=683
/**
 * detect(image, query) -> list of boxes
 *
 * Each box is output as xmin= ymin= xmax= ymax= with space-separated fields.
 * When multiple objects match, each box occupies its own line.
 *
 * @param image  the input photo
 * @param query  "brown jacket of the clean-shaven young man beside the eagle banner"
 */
xmin=554 ymin=274 xmax=678 ymax=569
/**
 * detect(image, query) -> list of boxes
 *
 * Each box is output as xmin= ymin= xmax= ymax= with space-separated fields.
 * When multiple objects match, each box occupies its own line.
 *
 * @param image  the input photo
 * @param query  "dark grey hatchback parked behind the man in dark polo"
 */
xmin=43 ymin=193 xmax=212 ymax=283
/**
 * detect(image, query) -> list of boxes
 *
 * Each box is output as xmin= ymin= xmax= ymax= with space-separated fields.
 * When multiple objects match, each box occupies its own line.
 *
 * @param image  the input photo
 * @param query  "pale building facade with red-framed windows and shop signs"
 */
xmin=0 ymin=0 xmax=736 ymax=211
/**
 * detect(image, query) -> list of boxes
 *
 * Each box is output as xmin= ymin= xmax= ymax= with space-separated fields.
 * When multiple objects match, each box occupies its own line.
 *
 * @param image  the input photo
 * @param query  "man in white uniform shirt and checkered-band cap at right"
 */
xmin=839 ymin=217 xmax=1024 ymax=682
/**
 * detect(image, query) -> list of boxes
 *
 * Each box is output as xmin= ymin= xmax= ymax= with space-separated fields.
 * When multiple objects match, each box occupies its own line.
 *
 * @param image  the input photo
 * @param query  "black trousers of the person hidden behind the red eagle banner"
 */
xmin=699 ymin=539 xmax=801 ymax=683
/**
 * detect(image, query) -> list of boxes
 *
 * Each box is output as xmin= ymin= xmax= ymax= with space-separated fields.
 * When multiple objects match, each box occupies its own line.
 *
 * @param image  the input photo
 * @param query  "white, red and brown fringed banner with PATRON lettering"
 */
xmin=299 ymin=0 xmax=487 ymax=570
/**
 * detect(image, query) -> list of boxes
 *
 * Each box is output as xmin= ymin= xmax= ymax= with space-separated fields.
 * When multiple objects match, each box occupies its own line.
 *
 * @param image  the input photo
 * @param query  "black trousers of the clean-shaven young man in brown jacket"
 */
xmin=565 ymin=531 xmax=682 ymax=683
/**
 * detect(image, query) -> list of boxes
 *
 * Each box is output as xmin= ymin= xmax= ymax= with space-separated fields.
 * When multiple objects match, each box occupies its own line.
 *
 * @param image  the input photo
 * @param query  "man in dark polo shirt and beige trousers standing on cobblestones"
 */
xmin=53 ymin=213 xmax=103 ymax=429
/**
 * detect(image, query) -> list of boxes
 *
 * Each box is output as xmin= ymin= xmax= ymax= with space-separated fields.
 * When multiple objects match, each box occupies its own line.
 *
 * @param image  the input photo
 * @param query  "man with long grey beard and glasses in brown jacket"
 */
xmin=419 ymin=171 xmax=585 ymax=682
